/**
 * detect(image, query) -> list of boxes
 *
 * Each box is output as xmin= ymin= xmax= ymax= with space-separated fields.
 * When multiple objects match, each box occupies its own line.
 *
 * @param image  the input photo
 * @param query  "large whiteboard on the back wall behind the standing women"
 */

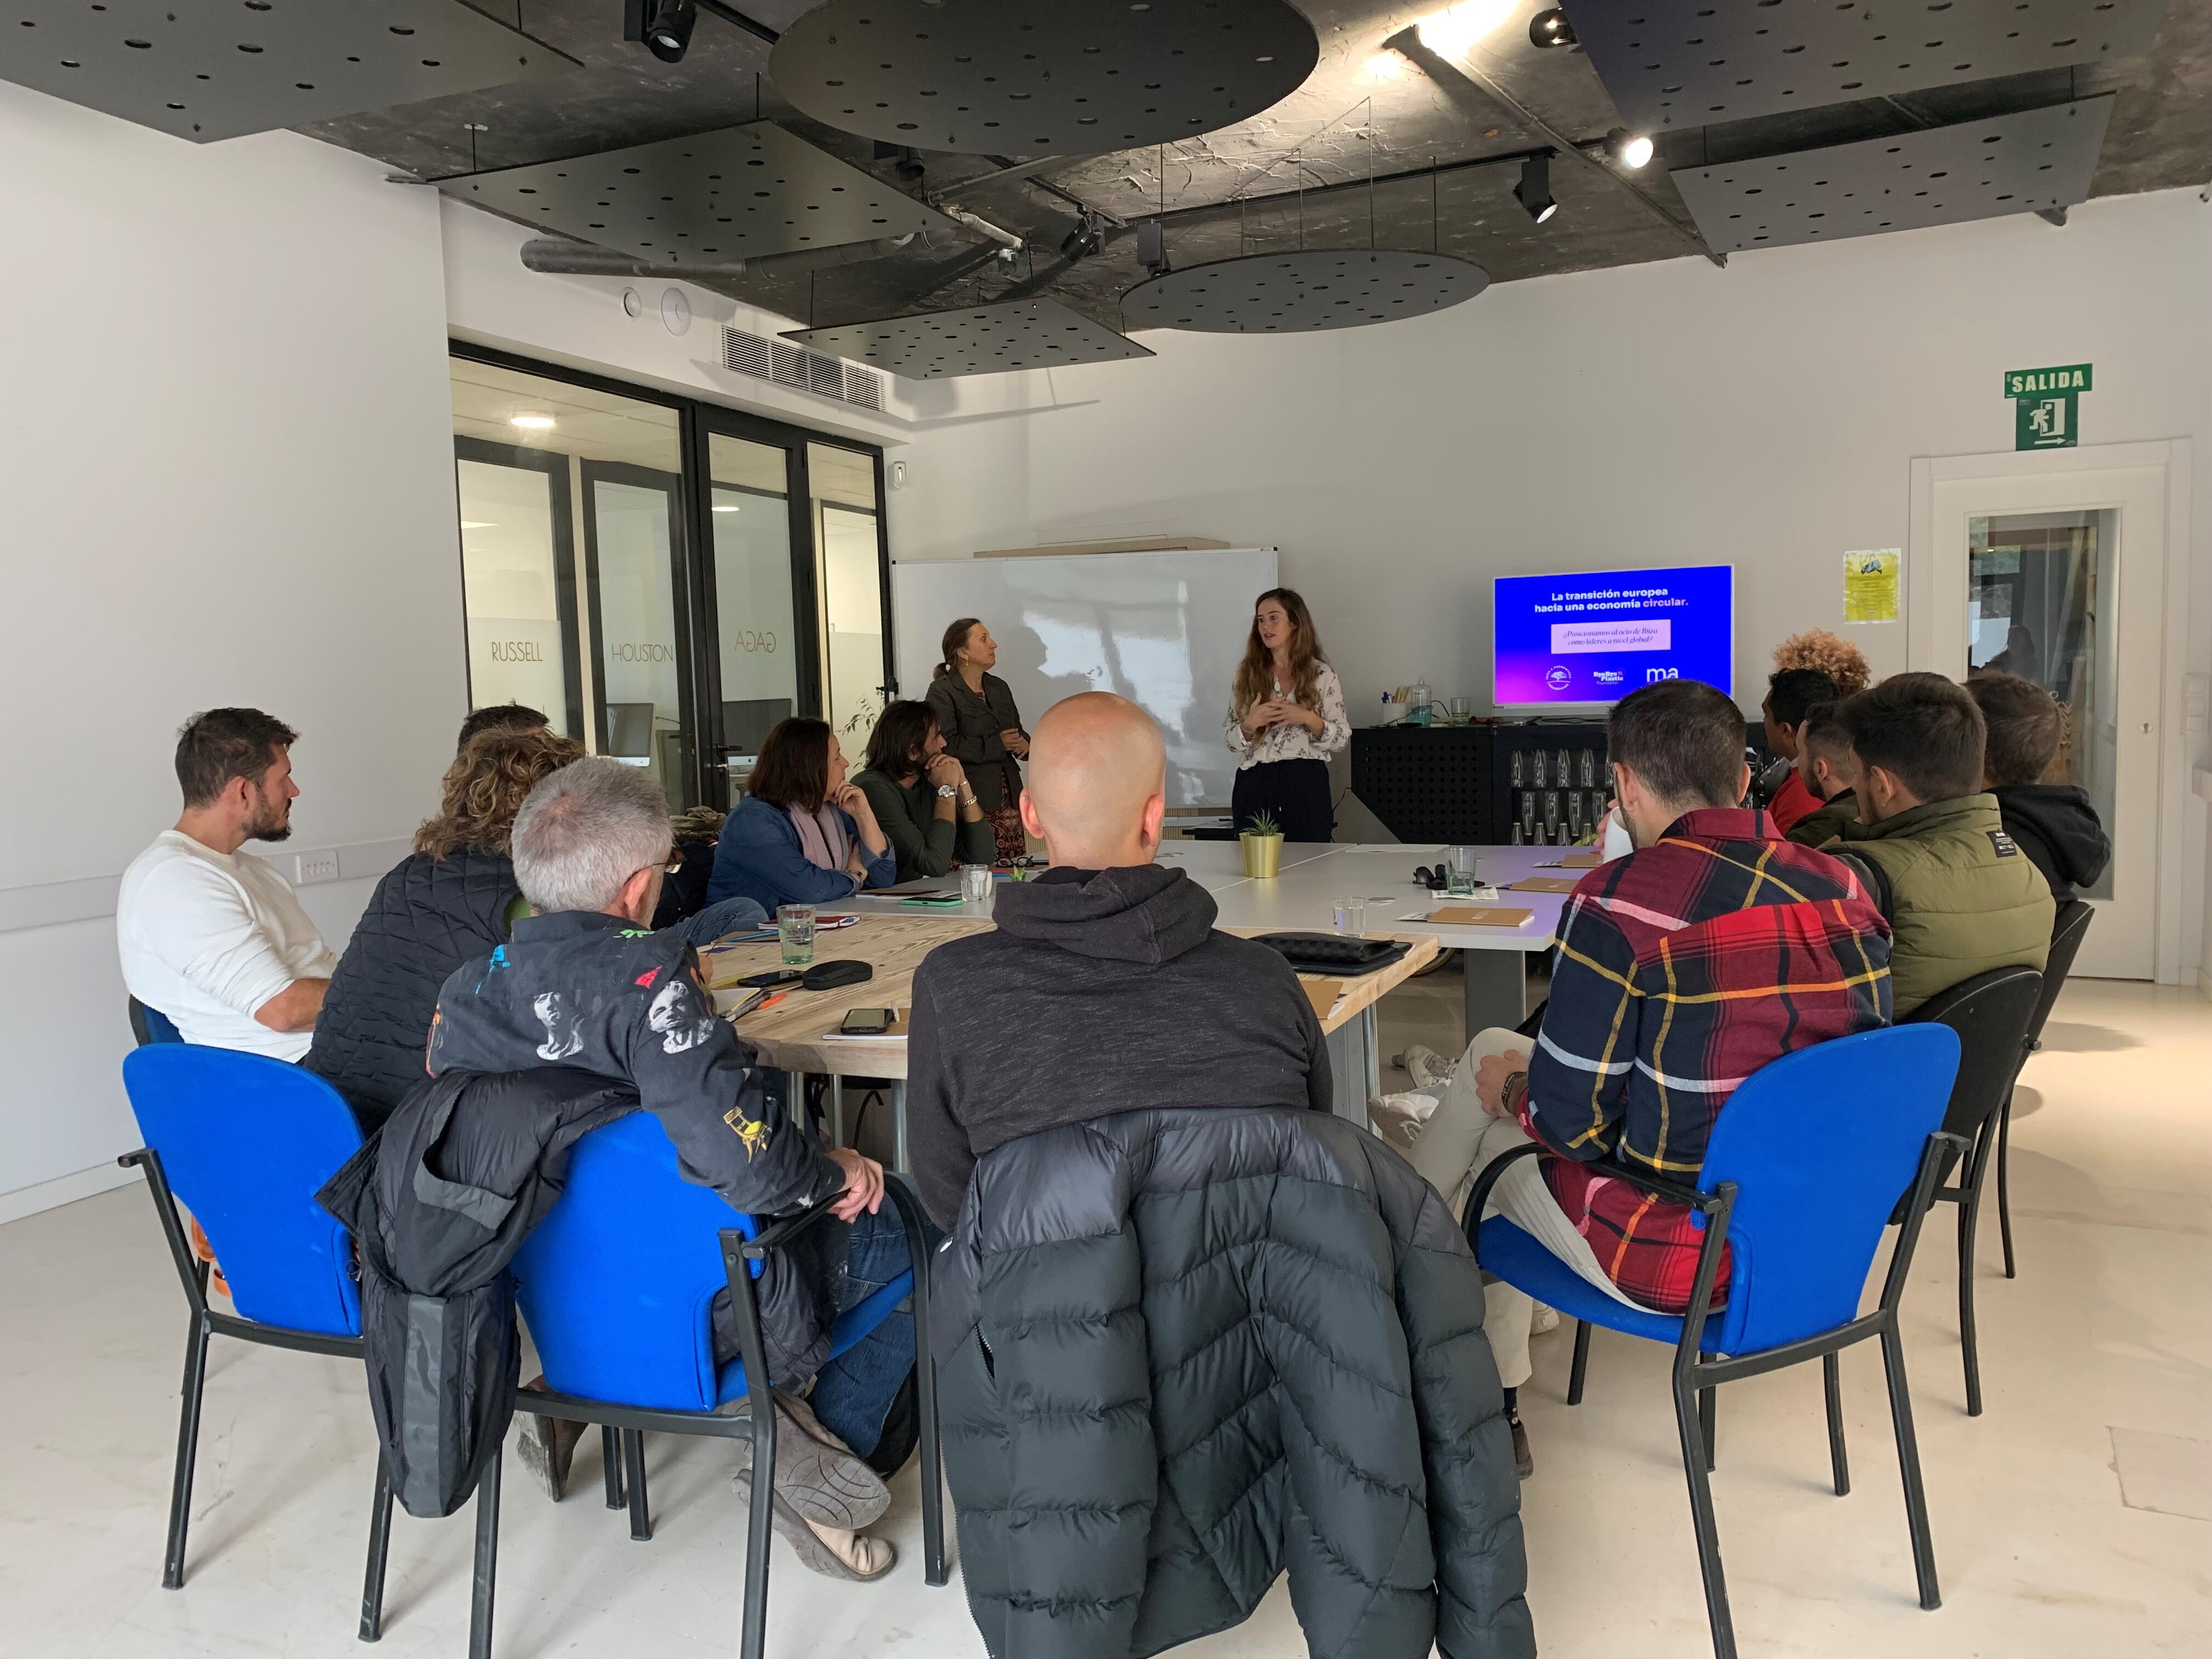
xmin=891 ymin=546 xmax=1276 ymax=808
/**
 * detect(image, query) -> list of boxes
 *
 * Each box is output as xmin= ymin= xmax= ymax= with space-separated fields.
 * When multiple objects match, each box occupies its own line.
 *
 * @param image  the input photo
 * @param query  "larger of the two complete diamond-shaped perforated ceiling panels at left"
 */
xmin=440 ymin=122 xmax=960 ymax=263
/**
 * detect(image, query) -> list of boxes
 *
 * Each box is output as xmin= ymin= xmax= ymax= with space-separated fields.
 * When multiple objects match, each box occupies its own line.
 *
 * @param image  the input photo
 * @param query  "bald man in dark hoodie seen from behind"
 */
xmin=907 ymin=692 xmax=1329 ymax=1232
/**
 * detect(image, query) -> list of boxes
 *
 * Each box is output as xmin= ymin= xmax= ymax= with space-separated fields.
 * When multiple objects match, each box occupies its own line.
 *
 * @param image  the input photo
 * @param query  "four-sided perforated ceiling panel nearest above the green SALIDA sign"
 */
xmin=1672 ymin=97 xmax=2113 ymax=252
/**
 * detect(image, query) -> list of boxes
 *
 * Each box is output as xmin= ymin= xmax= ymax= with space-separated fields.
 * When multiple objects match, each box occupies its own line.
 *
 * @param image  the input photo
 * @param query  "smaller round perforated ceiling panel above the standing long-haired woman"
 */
xmin=1121 ymin=248 xmax=1491 ymax=334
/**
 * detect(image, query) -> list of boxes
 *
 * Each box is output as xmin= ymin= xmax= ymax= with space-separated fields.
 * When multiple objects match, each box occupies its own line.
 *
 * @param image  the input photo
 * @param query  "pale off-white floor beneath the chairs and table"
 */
xmin=0 ymin=975 xmax=2212 ymax=1659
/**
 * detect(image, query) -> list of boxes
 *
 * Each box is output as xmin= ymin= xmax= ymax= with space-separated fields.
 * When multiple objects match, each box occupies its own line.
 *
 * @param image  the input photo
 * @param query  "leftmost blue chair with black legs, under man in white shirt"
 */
xmin=117 ymin=1044 xmax=392 ymax=1641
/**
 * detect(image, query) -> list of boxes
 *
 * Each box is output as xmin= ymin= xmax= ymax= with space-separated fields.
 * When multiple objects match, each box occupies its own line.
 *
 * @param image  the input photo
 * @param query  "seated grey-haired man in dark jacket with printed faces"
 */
xmin=429 ymin=759 xmax=913 ymax=1579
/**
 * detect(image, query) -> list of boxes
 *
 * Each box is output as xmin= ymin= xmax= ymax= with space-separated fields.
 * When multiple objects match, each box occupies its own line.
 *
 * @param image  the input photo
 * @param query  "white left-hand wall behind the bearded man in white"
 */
xmin=0 ymin=84 xmax=467 ymax=1215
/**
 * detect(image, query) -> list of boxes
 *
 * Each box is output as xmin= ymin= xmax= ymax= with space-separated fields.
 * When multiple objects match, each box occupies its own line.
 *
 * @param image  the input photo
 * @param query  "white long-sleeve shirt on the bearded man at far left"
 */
xmin=115 ymin=830 xmax=338 ymax=1059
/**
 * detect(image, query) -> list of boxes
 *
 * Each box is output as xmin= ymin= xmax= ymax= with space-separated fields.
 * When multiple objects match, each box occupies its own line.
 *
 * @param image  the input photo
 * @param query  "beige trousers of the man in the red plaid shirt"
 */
xmin=1407 ymin=1026 xmax=1637 ymax=1389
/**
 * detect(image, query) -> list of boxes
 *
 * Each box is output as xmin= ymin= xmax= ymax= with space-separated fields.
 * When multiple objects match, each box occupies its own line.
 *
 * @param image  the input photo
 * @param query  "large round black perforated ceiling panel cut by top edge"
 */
xmin=770 ymin=0 xmax=1321 ymax=155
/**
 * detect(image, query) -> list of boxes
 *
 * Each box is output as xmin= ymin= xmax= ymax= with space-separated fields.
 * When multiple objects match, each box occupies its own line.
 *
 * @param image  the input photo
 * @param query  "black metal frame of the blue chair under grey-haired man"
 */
xmin=462 ymin=1181 xmax=949 ymax=1659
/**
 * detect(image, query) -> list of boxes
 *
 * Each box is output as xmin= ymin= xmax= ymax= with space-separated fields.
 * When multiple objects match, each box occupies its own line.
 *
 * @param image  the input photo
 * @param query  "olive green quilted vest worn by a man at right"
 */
xmin=1829 ymin=794 xmax=2055 ymax=1020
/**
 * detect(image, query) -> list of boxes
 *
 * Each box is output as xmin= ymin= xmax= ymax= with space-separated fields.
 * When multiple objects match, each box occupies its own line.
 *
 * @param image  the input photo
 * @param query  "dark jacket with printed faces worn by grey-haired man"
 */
xmin=429 ymin=911 xmax=849 ymax=1385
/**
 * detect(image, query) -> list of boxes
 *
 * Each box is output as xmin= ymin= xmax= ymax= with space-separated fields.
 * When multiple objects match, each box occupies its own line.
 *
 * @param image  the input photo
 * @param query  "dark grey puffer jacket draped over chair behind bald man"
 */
xmin=929 ymin=1108 xmax=1535 ymax=1659
